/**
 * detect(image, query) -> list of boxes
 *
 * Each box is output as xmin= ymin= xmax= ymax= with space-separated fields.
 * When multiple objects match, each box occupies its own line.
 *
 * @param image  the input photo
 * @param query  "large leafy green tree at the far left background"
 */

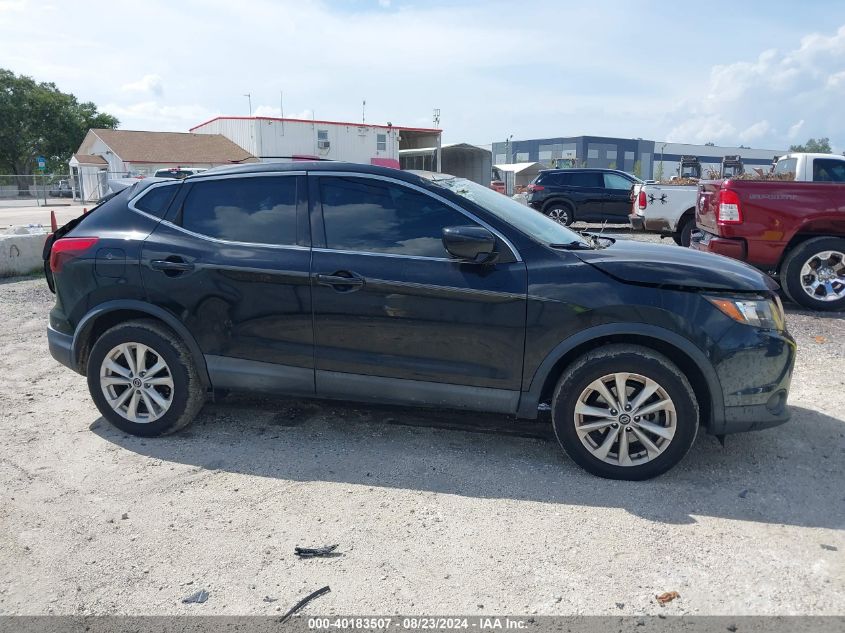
xmin=0 ymin=68 xmax=119 ymax=185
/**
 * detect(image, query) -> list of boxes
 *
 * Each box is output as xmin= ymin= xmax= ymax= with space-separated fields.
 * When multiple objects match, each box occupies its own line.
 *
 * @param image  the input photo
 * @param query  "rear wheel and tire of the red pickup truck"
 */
xmin=780 ymin=237 xmax=845 ymax=311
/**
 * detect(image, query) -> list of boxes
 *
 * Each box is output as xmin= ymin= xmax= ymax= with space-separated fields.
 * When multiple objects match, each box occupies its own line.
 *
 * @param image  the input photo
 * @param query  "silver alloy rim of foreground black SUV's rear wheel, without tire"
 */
xmin=100 ymin=343 xmax=173 ymax=424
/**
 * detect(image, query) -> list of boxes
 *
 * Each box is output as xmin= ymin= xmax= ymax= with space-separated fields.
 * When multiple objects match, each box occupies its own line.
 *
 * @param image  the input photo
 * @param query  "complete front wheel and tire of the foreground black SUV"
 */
xmin=552 ymin=345 xmax=699 ymax=481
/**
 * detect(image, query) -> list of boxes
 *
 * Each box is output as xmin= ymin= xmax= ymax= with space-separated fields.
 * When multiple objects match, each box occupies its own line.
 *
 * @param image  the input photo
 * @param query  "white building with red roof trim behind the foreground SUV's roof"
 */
xmin=191 ymin=116 xmax=441 ymax=169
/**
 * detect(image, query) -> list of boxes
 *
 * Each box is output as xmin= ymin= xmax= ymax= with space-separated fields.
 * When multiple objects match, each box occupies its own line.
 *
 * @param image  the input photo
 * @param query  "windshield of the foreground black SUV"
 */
xmin=433 ymin=177 xmax=591 ymax=248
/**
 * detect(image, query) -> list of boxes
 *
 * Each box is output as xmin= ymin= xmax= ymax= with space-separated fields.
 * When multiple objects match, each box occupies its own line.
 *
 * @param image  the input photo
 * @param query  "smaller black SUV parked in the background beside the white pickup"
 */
xmin=528 ymin=169 xmax=642 ymax=226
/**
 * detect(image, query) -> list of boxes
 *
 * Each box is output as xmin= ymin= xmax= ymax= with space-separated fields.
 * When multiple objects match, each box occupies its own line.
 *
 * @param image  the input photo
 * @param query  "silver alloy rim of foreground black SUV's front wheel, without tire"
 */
xmin=574 ymin=372 xmax=677 ymax=466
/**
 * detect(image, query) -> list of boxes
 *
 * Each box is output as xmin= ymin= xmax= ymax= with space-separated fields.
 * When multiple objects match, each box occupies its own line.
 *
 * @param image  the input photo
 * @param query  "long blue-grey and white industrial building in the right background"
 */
xmin=493 ymin=136 xmax=786 ymax=179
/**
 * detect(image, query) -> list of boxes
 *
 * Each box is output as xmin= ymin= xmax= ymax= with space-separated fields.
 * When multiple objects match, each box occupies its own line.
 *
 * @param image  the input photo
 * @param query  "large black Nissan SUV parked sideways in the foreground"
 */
xmin=45 ymin=162 xmax=795 ymax=479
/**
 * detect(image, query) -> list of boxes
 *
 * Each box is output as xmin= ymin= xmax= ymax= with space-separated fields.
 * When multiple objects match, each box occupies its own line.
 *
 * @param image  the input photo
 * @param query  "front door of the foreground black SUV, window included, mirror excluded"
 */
xmin=309 ymin=172 xmax=526 ymax=412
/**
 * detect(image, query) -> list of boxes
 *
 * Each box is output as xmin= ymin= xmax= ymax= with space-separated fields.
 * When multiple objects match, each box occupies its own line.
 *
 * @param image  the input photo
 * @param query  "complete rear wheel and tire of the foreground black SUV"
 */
xmin=87 ymin=320 xmax=205 ymax=437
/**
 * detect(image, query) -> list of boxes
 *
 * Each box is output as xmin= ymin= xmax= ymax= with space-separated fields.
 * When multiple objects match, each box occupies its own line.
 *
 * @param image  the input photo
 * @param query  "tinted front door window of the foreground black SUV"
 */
xmin=320 ymin=177 xmax=474 ymax=258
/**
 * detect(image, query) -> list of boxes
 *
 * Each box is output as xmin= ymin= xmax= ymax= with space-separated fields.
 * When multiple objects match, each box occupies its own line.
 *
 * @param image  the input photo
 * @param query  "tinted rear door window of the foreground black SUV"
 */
xmin=182 ymin=176 xmax=297 ymax=245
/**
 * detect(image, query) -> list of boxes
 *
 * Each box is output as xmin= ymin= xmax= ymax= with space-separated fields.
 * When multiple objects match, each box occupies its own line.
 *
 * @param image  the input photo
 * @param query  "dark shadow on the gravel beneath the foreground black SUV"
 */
xmin=91 ymin=396 xmax=845 ymax=529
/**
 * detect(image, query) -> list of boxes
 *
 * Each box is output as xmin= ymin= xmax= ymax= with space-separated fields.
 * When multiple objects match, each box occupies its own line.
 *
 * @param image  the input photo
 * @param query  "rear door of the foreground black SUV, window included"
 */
xmin=141 ymin=172 xmax=314 ymax=394
